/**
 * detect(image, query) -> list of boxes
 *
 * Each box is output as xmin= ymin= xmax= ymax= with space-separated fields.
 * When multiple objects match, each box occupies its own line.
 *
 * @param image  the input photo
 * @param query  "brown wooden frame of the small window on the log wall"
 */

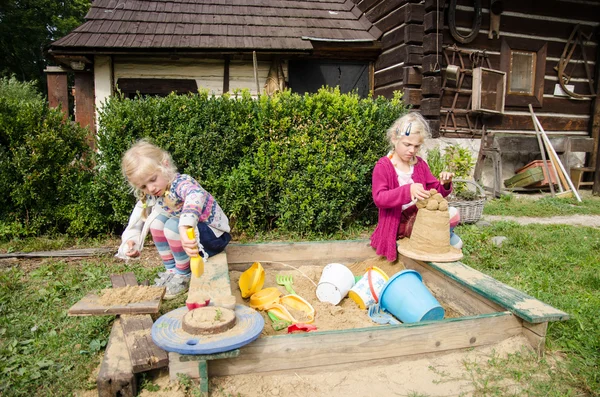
xmin=500 ymin=37 xmax=548 ymax=108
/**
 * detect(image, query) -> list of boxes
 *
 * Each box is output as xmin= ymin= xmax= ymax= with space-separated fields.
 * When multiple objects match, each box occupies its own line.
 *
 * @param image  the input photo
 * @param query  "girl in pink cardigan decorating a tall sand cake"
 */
xmin=371 ymin=112 xmax=462 ymax=261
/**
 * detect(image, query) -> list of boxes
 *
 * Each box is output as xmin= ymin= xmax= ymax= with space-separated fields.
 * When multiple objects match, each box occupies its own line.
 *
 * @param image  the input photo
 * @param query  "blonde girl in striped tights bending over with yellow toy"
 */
xmin=117 ymin=140 xmax=231 ymax=299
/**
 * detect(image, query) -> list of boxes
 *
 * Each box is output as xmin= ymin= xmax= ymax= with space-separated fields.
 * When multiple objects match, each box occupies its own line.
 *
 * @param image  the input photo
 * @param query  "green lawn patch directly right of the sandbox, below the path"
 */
xmin=457 ymin=222 xmax=600 ymax=396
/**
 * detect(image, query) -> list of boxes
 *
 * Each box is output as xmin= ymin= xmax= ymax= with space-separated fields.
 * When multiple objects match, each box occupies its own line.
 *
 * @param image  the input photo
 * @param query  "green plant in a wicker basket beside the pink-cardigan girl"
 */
xmin=427 ymin=144 xmax=485 ymax=223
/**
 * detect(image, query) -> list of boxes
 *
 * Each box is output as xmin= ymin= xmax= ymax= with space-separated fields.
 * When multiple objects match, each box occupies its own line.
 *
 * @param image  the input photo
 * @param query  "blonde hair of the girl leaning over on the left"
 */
xmin=121 ymin=139 xmax=177 ymax=202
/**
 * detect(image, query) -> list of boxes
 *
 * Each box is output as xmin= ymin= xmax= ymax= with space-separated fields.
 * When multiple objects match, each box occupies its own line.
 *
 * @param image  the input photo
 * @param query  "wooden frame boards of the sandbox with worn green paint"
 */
xmin=169 ymin=240 xmax=569 ymax=384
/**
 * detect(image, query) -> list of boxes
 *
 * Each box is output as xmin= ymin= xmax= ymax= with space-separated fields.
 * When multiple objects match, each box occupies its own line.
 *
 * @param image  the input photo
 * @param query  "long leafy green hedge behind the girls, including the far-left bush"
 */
xmin=0 ymin=79 xmax=405 ymax=240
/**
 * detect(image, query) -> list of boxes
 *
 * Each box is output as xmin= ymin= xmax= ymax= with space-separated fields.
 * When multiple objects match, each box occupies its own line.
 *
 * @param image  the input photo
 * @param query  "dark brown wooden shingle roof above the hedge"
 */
xmin=51 ymin=0 xmax=381 ymax=53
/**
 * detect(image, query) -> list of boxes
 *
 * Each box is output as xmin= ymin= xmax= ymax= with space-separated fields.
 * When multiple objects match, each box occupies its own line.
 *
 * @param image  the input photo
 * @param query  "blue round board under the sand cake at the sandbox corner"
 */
xmin=152 ymin=305 xmax=265 ymax=354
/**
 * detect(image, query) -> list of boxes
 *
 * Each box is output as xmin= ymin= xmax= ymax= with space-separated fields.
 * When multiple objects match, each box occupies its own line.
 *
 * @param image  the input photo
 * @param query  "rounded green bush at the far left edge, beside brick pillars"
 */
xmin=0 ymin=78 xmax=92 ymax=239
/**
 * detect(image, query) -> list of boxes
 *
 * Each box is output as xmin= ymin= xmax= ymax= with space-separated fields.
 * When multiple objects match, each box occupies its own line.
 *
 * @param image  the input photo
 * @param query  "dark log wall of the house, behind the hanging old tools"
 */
xmin=353 ymin=0 xmax=600 ymax=141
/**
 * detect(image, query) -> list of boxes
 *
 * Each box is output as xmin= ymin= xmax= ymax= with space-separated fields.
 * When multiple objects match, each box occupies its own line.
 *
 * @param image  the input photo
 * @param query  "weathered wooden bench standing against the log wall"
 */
xmin=473 ymin=133 xmax=595 ymax=197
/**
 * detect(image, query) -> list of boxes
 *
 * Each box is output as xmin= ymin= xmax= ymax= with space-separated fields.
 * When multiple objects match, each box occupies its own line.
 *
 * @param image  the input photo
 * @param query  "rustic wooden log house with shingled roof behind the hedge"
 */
xmin=48 ymin=0 xmax=600 ymax=194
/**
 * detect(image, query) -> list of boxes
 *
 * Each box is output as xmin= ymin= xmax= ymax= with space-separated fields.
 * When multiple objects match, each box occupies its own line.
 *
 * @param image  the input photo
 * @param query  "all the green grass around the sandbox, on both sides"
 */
xmin=0 ymin=196 xmax=600 ymax=396
